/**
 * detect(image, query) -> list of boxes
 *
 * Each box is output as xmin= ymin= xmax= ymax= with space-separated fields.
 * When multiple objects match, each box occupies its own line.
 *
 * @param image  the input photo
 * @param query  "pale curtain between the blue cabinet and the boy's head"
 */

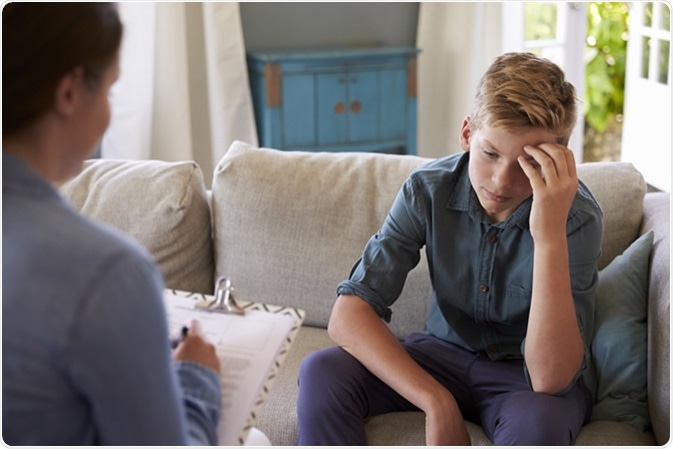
xmin=417 ymin=2 xmax=502 ymax=157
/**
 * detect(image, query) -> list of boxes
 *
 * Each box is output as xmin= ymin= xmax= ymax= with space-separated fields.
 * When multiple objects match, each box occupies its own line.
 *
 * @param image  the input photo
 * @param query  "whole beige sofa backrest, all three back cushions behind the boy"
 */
xmin=61 ymin=142 xmax=646 ymax=337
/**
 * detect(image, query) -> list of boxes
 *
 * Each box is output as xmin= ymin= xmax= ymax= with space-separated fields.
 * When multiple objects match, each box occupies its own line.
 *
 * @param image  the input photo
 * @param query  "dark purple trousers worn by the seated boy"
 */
xmin=297 ymin=334 xmax=592 ymax=446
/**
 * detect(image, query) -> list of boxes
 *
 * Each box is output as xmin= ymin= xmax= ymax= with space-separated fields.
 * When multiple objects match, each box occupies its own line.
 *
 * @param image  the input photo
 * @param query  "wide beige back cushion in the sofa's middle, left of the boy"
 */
xmin=212 ymin=142 xmax=431 ymax=337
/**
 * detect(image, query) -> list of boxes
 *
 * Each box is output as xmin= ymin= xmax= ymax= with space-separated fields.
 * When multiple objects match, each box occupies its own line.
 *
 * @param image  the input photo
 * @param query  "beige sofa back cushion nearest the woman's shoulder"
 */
xmin=60 ymin=159 xmax=214 ymax=293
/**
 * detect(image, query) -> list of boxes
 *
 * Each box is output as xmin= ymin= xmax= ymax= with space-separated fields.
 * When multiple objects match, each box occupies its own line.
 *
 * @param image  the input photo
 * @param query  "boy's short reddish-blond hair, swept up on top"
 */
xmin=470 ymin=53 xmax=577 ymax=145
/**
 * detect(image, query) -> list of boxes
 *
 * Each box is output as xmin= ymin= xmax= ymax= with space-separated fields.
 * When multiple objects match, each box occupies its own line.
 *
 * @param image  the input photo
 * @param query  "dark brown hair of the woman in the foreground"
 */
xmin=2 ymin=2 xmax=122 ymax=137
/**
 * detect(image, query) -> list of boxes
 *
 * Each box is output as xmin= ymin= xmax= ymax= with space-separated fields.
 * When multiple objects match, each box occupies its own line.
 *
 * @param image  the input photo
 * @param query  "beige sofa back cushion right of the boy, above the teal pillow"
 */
xmin=577 ymin=162 xmax=647 ymax=269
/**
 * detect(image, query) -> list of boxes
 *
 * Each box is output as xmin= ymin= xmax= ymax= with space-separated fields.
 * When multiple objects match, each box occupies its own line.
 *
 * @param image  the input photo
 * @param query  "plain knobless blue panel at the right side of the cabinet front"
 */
xmin=379 ymin=69 xmax=408 ymax=140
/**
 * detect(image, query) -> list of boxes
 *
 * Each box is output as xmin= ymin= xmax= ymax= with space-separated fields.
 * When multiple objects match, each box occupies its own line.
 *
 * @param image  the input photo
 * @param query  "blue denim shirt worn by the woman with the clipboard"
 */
xmin=2 ymin=153 xmax=220 ymax=446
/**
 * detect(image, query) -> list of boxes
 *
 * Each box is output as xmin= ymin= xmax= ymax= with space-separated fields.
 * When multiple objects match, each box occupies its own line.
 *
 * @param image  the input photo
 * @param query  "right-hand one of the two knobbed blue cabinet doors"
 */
xmin=347 ymin=71 xmax=381 ymax=142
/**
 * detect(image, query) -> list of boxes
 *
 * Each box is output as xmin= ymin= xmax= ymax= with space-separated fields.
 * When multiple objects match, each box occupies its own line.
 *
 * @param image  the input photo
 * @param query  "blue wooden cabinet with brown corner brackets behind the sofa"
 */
xmin=247 ymin=47 xmax=419 ymax=154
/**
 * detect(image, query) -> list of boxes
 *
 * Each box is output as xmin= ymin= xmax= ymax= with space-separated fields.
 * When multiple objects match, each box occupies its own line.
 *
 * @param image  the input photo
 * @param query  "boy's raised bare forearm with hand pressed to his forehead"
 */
xmin=519 ymin=144 xmax=584 ymax=394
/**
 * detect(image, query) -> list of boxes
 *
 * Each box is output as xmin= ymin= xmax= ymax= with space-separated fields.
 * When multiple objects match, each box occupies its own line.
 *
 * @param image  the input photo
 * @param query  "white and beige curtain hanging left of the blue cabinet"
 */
xmin=101 ymin=2 xmax=257 ymax=185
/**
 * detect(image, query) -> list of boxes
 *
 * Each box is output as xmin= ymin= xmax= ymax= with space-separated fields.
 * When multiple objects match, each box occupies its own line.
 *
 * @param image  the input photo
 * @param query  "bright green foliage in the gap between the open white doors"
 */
xmin=584 ymin=2 xmax=629 ymax=133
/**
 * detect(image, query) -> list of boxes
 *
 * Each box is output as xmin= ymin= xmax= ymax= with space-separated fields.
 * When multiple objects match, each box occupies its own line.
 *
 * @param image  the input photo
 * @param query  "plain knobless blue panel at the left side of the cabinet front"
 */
xmin=282 ymin=74 xmax=316 ymax=149
